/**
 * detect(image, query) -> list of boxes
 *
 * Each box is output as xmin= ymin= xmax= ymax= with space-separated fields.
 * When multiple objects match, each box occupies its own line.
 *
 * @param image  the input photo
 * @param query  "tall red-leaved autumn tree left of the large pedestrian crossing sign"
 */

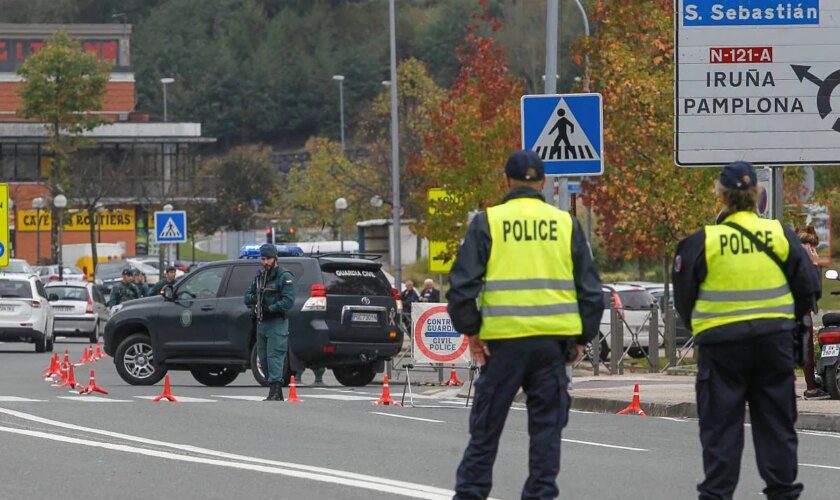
xmin=409 ymin=0 xmax=523 ymax=255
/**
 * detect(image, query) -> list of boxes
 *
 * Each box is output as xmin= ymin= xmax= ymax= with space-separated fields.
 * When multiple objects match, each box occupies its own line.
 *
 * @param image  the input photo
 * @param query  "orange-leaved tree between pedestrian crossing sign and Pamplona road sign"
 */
xmin=575 ymin=0 xmax=719 ymax=274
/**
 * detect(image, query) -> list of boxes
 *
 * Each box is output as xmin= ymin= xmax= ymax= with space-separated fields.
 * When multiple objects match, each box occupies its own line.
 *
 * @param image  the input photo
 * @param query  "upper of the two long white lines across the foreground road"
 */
xmin=0 ymin=408 xmax=454 ymax=498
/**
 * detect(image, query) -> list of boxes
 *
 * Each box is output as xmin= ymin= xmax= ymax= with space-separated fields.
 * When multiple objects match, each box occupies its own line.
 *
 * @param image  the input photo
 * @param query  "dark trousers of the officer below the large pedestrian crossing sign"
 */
xmin=455 ymin=337 xmax=569 ymax=499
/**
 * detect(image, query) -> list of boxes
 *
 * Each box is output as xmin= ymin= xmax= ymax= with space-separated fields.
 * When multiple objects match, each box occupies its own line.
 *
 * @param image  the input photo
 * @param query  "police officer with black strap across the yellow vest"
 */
xmin=673 ymin=162 xmax=820 ymax=499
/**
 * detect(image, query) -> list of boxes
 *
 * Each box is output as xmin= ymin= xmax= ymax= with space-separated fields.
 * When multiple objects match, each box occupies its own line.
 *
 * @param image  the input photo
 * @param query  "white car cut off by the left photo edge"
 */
xmin=0 ymin=273 xmax=55 ymax=352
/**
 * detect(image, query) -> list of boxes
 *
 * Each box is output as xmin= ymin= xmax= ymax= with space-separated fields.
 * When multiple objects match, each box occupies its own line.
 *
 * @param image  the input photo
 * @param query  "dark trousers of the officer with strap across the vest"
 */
xmin=697 ymin=332 xmax=802 ymax=499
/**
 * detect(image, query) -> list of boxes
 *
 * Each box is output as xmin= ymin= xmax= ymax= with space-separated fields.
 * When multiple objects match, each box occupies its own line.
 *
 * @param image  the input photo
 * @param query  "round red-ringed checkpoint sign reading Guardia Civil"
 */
xmin=414 ymin=306 xmax=469 ymax=363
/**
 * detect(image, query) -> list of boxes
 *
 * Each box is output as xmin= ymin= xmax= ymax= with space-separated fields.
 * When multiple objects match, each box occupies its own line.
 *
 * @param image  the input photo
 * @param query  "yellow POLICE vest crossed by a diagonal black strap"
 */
xmin=691 ymin=212 xmax=794 ymax=335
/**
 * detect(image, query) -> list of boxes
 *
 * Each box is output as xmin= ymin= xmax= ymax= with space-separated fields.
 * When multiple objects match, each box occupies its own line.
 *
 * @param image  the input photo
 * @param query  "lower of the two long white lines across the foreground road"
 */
xmin=0 ymin=426 xmax=454 ymax=500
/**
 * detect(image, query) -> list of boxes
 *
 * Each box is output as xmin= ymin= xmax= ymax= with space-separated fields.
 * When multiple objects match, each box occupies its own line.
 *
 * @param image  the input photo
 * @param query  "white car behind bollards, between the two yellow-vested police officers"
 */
xmin=599 ymin=283 xmax=664 ymax=361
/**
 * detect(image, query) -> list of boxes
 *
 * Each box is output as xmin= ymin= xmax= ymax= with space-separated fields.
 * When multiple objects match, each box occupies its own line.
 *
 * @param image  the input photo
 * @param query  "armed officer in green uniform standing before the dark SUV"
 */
xmin=245 ymin=244 xmax=295 ymax=401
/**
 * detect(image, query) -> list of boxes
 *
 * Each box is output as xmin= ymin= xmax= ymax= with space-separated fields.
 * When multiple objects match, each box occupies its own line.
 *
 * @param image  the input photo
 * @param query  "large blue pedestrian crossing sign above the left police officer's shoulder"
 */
xmin=522 ymin=94 xmax=604 ymax=176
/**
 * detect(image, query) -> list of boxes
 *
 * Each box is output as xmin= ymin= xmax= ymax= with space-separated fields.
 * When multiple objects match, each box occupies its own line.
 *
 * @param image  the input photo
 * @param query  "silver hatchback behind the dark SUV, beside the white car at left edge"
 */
xmin=44 ymin=280 xmax=111 ymax=344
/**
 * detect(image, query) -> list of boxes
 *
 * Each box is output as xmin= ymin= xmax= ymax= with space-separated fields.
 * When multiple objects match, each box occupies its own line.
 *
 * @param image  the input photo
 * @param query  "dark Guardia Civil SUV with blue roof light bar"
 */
xmin=104 ymin=255 xmax=403 ymax=386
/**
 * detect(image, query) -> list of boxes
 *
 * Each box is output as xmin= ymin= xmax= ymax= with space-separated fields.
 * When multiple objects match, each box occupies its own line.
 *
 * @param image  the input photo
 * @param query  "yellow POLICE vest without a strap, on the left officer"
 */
xmin=479 ymin=198 xmax=583 ymax=340
